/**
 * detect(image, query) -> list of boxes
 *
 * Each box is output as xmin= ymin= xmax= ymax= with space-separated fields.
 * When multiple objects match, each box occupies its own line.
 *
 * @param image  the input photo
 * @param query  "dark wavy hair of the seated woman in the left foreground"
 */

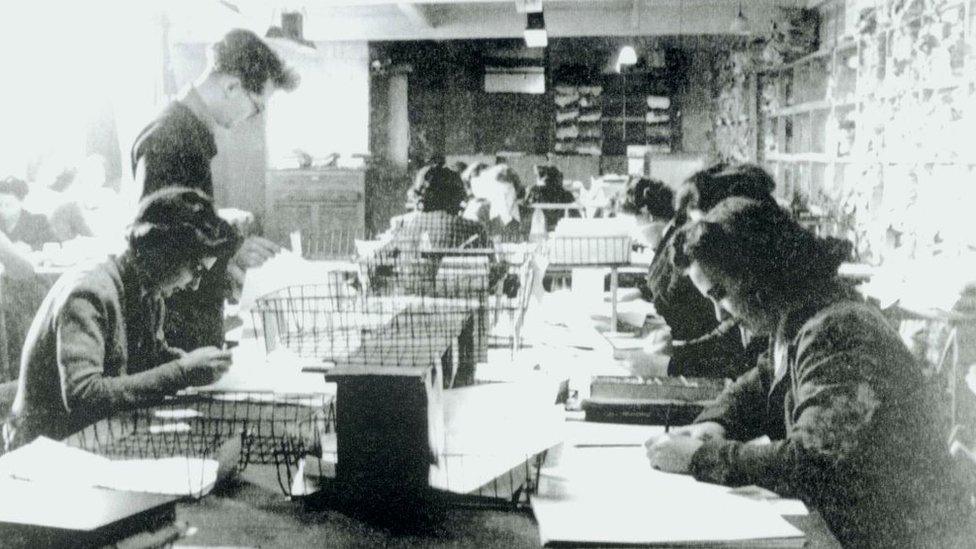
xmin=126 ymin=187 xmax=241 ymax=284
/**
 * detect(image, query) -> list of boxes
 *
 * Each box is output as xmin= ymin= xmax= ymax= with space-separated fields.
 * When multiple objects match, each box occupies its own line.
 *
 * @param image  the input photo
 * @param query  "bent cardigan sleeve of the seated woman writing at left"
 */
xmin=57 ymin=297 xmax=187 ymax=417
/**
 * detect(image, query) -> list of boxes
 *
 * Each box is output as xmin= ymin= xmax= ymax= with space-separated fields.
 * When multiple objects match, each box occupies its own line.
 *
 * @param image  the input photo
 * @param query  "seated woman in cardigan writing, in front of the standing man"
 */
xmin=4 ymin=187 xmax=239 ymax=449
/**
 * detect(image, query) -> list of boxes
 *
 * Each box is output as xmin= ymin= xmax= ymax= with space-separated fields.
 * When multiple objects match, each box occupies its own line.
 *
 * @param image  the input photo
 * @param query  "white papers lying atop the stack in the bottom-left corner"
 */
xmin=0 ymin=437 xmax=219 ymax=497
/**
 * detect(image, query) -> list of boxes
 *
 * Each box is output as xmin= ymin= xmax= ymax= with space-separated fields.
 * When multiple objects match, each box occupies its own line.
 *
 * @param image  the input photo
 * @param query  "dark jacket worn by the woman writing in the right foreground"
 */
xmin=691 ymin=290 xmax=970 ymax=547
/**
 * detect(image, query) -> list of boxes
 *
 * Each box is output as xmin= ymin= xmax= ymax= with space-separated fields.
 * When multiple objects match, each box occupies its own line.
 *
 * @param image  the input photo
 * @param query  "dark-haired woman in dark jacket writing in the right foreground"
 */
xmin=647 ymin=198 xmax=976 ymax=548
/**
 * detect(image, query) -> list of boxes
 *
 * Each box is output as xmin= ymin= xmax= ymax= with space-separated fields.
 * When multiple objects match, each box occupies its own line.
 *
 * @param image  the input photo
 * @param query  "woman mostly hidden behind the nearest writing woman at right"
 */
xmin=641 ymin=163 xmax=775 ymax=378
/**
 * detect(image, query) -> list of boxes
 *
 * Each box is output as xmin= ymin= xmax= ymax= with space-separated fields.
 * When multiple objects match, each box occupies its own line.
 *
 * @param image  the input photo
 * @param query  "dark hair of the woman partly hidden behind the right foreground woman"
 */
xmin=674 ymin=162 xmax=776 ymax=225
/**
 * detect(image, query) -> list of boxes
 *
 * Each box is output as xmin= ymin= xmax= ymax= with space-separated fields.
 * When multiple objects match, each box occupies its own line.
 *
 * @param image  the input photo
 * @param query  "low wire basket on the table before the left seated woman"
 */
xmin=65 ymin=392 xmax=335 ymax=493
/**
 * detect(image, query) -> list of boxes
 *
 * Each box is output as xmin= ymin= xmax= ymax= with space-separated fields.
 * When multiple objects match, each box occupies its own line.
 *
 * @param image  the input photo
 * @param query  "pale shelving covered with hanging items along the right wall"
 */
xmin=757 ymin=0 xmax=976 ymax=256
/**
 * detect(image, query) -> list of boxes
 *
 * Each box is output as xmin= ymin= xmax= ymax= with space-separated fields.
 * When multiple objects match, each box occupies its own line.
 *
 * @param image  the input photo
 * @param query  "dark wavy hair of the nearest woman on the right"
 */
xmin=673 ymin=197 xmax=853 ymax=303
